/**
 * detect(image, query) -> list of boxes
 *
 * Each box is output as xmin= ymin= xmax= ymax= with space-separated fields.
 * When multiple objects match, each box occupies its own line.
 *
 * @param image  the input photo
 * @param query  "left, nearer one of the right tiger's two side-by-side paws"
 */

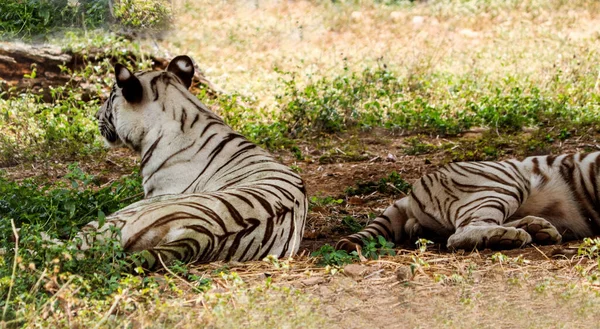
xmin=447 ymin=226 xmax=532 ymax=250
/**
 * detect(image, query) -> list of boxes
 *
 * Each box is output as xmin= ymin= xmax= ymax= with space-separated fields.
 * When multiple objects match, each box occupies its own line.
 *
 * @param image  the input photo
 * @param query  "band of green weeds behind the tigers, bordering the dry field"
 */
xmin=205 ymin=68 xmax=600 ymax=153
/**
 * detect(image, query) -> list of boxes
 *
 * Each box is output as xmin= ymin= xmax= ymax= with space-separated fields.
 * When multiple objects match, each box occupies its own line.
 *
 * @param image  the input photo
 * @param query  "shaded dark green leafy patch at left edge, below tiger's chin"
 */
xmin=0 ymin=164 xmax=142 ymax=237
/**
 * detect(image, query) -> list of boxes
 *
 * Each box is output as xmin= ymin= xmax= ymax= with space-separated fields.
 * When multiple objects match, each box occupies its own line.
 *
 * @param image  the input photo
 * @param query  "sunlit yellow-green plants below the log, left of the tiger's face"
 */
xmin=0 ymin=87 xmax=102 ymax=165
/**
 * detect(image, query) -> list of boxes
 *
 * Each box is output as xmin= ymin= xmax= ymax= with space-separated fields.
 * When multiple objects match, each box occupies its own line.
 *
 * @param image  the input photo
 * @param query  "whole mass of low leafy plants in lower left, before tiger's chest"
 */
xmin=0 ymin=165 xmax=142 ymax=319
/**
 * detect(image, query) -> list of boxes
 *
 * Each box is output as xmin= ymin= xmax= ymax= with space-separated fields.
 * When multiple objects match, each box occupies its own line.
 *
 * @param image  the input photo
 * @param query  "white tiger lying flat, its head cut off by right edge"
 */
xmin=336 ymin=152 xmax=600 ymax=251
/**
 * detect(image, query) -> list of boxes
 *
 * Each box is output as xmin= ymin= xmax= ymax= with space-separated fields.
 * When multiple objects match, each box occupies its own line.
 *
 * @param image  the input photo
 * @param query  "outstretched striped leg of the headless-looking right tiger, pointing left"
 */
xmin=335 ymin=197 xmax=419 ymax=252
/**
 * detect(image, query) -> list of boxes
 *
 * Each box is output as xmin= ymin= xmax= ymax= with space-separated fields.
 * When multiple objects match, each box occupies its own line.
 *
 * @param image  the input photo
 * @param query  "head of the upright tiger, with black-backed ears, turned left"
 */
xmin=96 ymin=56 xmax=194 ymax=153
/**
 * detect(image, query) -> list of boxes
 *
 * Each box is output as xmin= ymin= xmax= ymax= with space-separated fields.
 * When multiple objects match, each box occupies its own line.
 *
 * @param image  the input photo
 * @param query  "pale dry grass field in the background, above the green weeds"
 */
xmin=161 ymin=0 xmax=600 ymax=105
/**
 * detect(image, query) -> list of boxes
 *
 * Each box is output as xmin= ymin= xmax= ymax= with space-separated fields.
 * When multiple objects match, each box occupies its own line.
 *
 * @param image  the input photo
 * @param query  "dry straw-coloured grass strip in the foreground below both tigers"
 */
xmin=12 ymin=247 xmax=600 ymax=328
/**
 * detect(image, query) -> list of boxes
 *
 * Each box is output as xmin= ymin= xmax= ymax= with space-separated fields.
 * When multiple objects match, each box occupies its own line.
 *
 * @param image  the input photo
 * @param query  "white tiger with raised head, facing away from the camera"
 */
xmin=79 ymin=56 xmax=307 ymax=267
